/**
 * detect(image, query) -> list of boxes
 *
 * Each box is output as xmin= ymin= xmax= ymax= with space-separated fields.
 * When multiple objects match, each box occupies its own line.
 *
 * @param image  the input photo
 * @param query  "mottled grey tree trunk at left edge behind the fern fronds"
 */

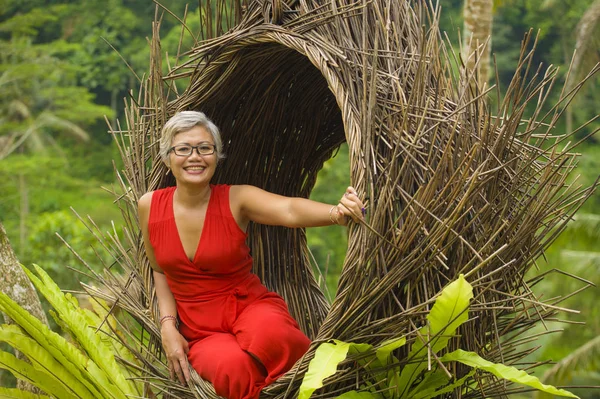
xmin=0 ymin=222 xmax=48 ymax=393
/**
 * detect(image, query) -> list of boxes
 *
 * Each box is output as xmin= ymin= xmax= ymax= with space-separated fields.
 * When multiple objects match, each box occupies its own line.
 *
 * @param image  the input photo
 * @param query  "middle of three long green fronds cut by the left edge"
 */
xmin=0 ymin=325 xmax=94 ymax=399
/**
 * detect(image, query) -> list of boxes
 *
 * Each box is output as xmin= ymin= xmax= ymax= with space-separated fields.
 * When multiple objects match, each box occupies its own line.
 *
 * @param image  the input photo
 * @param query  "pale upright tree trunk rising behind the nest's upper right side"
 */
xmin=462 ymin=0 xmax=494 ymax=87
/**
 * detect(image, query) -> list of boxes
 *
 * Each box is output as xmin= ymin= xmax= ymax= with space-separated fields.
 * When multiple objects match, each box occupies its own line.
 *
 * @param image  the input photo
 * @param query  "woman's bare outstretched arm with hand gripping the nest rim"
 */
xmin=230 ymin=185 xmax=364 ymax=227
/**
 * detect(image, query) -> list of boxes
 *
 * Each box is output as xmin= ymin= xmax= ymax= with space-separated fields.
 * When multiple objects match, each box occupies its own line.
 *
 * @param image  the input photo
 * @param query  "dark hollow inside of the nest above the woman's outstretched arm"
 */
xmin=184 ymin=42 xmax=346 ymax=197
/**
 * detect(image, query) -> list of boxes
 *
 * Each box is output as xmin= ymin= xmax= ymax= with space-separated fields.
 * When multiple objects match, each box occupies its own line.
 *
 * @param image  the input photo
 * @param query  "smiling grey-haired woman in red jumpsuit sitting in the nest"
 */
xmin=138 ymin=111 xmax=364 ymax=399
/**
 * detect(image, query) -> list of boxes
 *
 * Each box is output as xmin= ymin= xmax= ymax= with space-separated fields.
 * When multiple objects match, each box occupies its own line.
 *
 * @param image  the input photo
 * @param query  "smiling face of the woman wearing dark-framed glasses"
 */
xmin=169 ymin=126 xmax=217 ymax=185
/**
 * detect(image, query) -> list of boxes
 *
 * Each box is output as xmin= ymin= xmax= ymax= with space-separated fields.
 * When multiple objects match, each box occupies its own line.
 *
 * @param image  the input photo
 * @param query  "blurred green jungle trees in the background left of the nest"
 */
xmin=0 ymin=0 xmax=203 ymax=300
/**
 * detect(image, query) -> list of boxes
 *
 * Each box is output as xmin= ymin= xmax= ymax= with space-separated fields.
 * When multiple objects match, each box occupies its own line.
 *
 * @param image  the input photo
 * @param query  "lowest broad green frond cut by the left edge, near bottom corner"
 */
xmin=0 ymin=351 xmax=73 ymax=399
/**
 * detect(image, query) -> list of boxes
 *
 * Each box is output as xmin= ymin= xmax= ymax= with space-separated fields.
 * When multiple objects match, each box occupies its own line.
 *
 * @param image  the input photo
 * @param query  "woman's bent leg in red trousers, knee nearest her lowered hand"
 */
xmin=188 ymin=333 xmax=265 ymax=399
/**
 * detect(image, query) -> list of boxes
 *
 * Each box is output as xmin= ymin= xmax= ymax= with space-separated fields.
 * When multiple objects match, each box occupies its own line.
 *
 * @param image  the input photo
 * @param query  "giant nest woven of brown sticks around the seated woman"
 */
xmin=88 ymin=0 xmax=593 ymax=398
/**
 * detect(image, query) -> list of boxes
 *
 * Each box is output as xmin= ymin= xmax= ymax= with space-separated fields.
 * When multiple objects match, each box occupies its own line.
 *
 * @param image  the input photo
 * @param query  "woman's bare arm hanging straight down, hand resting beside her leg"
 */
xmin=138 ymin=192 xmax=190 ymax=384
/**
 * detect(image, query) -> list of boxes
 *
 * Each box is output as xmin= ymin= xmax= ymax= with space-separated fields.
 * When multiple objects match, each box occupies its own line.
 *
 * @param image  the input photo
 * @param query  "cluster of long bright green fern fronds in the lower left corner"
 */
xmin=0 ymin=266 xmax=141 ymax=399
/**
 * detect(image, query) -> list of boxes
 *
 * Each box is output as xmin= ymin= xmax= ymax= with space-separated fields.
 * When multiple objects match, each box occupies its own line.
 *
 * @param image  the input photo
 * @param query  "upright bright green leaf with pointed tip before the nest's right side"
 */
xmin=397 ymin=274 xmax=473 ymax=398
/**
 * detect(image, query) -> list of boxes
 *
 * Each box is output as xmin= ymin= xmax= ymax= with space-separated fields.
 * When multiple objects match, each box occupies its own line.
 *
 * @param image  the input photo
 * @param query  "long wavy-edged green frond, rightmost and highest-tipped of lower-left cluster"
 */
xmin=23 ymin=265 xmax=138 ymax=399
